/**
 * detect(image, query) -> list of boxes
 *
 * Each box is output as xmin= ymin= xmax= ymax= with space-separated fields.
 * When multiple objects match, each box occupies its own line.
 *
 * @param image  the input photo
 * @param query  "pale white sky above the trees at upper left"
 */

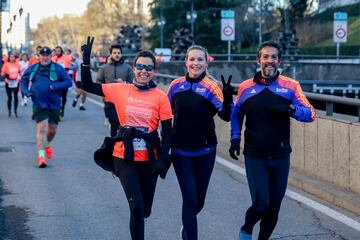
xmin=21 ymin=0 xmax=90 ymax=28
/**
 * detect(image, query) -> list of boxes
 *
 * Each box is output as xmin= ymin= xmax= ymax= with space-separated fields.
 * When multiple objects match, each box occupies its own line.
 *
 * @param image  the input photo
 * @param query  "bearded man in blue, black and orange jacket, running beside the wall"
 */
xmin=229 ymin=42 xmax=316 ymax=240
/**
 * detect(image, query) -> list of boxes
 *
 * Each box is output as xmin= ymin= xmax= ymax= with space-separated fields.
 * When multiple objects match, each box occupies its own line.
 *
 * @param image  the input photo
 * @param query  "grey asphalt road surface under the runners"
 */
xmin=0 ymin=88 xmax=360 ymax=240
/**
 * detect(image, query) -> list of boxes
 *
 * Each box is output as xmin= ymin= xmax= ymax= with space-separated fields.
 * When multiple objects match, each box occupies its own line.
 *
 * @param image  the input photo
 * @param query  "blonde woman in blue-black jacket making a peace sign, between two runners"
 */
xmin=168 ymin=45 xmax=234 ymax=240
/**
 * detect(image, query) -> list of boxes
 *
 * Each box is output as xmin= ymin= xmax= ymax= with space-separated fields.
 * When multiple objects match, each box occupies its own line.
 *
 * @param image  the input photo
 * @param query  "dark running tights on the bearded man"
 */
xmin=242 ymin=155 xmax=290 ymax=240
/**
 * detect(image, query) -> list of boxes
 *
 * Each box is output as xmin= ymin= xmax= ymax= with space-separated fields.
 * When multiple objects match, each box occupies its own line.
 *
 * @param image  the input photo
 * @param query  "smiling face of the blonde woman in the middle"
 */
xmin=185 ymin=49 xmax=208 ymax=78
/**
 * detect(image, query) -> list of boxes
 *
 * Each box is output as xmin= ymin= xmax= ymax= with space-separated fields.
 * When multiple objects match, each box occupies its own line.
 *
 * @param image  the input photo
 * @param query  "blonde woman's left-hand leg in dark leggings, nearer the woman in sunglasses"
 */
xmin=173 ymin=153 xmax=198 ymax=240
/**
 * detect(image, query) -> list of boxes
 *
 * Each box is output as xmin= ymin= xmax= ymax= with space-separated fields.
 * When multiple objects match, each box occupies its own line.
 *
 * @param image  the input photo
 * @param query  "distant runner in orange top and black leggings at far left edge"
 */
xmin=1 ymin=53 xmax=21 ymax=118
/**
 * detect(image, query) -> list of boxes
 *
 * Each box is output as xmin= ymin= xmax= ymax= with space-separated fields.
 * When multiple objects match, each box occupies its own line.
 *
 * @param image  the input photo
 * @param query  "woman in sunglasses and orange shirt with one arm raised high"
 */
xmin=81 ymin=37 xmax=172 ymax=240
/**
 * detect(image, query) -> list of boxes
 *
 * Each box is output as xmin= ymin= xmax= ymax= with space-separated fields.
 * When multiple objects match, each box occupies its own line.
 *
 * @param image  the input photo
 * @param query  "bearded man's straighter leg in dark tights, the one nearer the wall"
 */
xmin=259 ymin=155 xmax=290 ymax=240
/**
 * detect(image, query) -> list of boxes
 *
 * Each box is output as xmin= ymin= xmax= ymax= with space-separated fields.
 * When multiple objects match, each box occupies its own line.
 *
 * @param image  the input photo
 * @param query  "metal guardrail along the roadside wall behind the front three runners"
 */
xmin=154 ymin=73 xmax=360 ymax=122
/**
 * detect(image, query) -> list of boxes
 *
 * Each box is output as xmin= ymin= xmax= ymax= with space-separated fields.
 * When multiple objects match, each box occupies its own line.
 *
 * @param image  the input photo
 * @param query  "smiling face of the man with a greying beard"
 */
xmin=256 ymin=47 xmax=280 ymax=78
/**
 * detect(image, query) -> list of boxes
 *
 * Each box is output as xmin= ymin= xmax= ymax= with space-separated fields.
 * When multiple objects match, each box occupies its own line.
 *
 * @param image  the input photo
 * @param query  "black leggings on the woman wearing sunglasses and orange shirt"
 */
xmin=114 ymin=157 xmax=157 ymax=240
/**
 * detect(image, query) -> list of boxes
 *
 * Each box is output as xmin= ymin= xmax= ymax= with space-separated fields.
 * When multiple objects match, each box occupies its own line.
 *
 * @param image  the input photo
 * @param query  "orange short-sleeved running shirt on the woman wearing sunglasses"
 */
xmin=102 ymin=83 xmax=172 ymax=161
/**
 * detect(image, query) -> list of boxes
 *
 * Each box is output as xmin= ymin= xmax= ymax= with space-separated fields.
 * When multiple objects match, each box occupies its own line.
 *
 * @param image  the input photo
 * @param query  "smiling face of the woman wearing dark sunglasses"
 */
xmin=133 ymin=57 xmax=154 ymax=84
